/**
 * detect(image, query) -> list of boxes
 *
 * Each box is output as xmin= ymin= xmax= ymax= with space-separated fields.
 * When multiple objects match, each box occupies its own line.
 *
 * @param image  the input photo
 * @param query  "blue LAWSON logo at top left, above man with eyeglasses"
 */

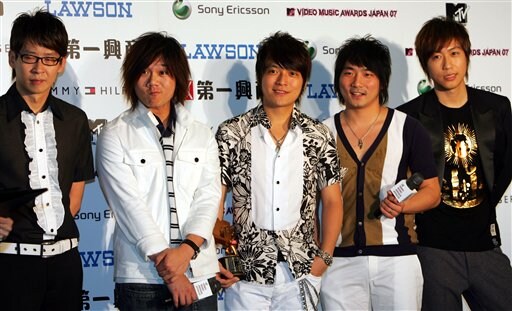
xmin=44 ymin=0 xmax=133 ymax=18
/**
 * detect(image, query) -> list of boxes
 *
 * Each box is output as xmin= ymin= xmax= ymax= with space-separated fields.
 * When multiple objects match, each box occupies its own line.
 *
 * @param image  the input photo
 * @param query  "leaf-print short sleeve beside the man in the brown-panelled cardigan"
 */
xmin=318 ymin=124 xmax=341 ymax=190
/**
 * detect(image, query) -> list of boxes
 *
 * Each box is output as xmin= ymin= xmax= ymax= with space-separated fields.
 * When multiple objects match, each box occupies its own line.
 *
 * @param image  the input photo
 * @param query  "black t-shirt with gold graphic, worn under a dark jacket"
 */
xmin=416 ymin=102 xmax=500 ymax=251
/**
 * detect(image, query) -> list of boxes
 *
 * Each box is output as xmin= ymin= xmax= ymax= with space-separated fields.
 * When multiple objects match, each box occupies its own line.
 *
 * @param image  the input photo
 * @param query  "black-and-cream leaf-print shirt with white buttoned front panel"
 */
xmin=217 ymin=106 xmax=340 ymax=284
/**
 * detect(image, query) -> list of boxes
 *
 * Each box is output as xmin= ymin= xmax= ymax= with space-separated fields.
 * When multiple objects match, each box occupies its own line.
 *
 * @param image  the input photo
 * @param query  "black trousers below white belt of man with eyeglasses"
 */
xmin=0 ymin=248 xmax=83 ymax=311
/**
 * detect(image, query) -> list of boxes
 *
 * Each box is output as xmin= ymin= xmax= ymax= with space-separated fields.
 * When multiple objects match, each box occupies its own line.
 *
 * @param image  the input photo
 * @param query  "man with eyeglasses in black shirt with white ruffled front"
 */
xmin=0 ymin=10 xmax=94 ymax=310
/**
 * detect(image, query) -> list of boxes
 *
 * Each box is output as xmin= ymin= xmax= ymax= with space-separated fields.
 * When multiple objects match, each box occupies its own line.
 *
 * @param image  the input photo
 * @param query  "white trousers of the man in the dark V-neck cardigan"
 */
xmin=320 ymin=255 xmax=423 ymax=310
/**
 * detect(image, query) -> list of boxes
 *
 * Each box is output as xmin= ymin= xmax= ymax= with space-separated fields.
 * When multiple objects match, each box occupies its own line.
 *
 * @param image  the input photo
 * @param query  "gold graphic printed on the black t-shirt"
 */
xmin=441 ymin=123 xmax=485 ymax=208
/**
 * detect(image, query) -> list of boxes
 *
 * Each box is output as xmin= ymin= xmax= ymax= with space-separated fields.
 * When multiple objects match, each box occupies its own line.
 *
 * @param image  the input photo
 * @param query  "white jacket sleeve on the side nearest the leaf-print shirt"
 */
xmin=183 ymin=129 xmax=221 ymax=248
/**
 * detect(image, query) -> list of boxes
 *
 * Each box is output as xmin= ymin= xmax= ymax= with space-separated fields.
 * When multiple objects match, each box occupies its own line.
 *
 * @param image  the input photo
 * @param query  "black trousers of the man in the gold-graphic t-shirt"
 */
xmin=418 ymin=247 xmax=512 ymax=311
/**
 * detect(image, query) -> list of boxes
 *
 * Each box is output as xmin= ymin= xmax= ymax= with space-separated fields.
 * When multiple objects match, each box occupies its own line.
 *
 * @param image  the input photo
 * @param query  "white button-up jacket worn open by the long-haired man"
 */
xmin=96 ymin=102 xmax=221 ymax=283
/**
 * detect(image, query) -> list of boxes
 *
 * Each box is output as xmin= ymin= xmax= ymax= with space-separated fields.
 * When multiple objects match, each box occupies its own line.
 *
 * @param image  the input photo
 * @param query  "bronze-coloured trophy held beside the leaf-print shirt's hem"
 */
xmin=213 ymin=219 xmax=245 ymax=280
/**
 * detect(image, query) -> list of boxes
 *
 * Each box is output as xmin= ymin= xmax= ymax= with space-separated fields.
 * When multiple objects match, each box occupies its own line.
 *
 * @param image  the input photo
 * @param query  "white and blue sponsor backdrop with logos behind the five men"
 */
xmin=0 ymin=0 xmax=512 ymax=310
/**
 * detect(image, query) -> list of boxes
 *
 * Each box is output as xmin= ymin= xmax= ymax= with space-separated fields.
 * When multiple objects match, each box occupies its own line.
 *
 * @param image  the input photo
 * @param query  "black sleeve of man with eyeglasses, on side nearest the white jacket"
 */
xmin=73 ymin=113 xmax=94 ymax=182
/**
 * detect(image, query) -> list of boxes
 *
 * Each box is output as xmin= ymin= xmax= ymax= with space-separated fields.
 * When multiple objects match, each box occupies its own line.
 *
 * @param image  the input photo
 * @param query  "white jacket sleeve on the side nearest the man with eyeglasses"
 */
xmin=96 ymin=125 xmax=168 ymax=260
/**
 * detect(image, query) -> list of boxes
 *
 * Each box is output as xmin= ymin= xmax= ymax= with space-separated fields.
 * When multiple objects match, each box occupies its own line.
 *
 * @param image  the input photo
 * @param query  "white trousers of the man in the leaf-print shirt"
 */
xmin=224 ymin=262 xmax=322 ymax=311
